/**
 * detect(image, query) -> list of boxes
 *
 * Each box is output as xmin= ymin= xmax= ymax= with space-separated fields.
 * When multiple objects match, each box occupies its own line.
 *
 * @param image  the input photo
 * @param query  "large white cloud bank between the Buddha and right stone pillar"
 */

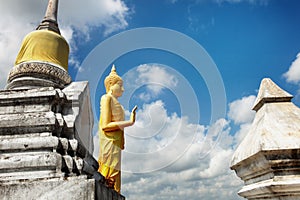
xmin=95 ymin=101 xmax=241 ymax=200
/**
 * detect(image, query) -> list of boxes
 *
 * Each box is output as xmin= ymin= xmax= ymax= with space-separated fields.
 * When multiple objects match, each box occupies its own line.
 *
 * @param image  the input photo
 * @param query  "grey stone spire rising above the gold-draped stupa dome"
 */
xmin=36 ymin=0 xmax=60 ymax=34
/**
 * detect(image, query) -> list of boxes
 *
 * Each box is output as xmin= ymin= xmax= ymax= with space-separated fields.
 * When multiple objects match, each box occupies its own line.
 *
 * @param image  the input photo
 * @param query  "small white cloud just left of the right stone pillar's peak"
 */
xmin=228 ymin=95 xmax=256 ymax=124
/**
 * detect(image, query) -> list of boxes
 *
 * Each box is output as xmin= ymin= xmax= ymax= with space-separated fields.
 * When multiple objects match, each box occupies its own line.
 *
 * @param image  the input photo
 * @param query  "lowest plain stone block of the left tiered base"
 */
xmin=0 ymin=176 xmax=95 ymax=200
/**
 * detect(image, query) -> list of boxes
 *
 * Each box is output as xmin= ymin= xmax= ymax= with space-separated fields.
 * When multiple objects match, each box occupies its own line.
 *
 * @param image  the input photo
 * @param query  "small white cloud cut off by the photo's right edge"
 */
xmin=283 ymin=53 xmax=300 ymax=84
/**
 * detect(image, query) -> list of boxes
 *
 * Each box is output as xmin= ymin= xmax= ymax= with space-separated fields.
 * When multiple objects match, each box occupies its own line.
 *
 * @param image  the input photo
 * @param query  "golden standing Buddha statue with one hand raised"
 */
xmin=98 ymin=65 xmax=137 ymax=193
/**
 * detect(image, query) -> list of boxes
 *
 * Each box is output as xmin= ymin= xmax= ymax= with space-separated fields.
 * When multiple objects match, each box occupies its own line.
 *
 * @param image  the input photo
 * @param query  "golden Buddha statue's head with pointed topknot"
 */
xmin=104 ymin=65 xmax=124 ymax=97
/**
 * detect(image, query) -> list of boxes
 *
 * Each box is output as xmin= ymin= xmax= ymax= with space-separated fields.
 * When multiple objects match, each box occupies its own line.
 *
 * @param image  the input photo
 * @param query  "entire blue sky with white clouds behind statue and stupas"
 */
xmin=0 ymin=0 xmax=300 ymax=200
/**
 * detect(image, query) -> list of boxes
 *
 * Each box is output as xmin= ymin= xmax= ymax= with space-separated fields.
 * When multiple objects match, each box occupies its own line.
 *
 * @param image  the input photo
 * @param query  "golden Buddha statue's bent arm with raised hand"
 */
xmin=101 ymin=96 xmax=135 ymax=131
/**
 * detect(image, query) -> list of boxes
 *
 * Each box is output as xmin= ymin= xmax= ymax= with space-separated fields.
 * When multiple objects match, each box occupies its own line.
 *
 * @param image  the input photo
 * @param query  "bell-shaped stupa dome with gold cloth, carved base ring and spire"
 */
xmin=6 ymin=0 xmax=72 ymax=89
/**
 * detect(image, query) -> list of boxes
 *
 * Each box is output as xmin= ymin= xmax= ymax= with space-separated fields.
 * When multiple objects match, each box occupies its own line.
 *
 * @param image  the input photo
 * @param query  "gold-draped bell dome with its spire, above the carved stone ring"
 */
xmin=15 ymin=0 xmax=69 ymax=71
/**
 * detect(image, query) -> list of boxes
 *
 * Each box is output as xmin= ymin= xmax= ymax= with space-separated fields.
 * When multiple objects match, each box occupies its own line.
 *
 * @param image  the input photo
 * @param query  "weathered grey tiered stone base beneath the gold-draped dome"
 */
xmin=0 ymin=82 xmax=125 ymax=200
